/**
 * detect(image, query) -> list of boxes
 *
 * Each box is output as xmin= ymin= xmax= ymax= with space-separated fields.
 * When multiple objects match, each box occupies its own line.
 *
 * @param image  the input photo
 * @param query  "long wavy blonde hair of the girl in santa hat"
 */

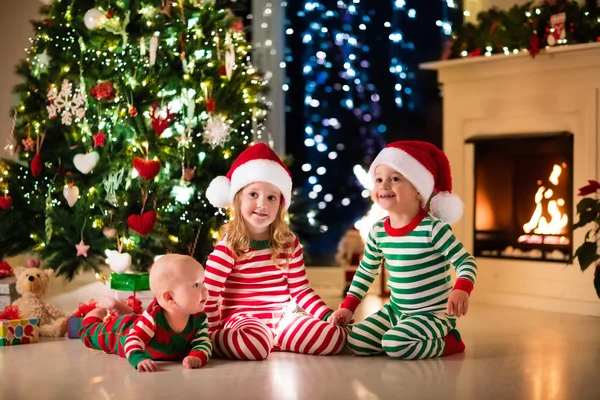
xmin=221 ymin=189 xmax=295 ymax=268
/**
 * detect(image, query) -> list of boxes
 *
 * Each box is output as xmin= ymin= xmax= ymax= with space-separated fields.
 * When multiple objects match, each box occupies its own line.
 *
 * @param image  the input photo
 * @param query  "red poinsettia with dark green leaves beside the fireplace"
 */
xmin=573 ymin=180 xmax=600 ymax=297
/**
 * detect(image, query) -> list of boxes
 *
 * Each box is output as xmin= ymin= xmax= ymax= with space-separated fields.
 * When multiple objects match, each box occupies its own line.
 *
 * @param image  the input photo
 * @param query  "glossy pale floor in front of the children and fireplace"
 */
xmin=0 ymin=287 xmax=600 ymax=400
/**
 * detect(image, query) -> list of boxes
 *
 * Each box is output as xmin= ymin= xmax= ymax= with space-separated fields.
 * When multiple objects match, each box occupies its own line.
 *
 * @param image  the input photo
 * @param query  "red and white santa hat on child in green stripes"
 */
xmin=369 ymin=140 xmax=463 ymax=224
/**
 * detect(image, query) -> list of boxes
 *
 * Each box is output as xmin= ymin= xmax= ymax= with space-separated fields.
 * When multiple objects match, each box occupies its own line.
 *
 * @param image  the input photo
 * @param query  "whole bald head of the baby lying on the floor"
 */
xmin=150 ymin=254 xmax=208 ymax=315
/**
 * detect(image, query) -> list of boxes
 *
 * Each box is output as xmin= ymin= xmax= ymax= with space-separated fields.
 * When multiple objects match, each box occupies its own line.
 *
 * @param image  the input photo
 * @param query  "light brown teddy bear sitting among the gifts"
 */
xmin=13 ymin=267 xmax=68 ymax=337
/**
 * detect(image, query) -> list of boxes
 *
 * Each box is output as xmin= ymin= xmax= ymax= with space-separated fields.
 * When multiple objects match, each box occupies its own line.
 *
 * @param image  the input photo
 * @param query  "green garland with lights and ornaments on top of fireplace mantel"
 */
xmin=442 ymin=0 xmax=600 ymax=59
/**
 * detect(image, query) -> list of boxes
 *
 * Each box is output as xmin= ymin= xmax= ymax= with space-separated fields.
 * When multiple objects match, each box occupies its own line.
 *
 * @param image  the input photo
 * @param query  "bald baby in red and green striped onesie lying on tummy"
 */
xmin=79 ymin=254 xmax=212 ymax=372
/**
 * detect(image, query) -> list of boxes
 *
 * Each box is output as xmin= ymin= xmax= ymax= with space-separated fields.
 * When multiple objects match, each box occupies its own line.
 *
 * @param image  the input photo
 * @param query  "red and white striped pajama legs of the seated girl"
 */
xmin=211 ymin=314 xmax=348 ymax=360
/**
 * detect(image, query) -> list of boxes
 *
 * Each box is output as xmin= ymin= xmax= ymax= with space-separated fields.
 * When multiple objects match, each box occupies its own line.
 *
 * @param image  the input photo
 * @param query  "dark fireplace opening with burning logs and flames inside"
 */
xmin=466 ymin=132 xmax=573 ymax=262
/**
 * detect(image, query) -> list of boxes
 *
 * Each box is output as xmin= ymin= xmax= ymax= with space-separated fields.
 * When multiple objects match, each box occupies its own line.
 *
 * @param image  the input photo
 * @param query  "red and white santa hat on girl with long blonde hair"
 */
xmin=206 ymin=143 xmax=292 ymax=210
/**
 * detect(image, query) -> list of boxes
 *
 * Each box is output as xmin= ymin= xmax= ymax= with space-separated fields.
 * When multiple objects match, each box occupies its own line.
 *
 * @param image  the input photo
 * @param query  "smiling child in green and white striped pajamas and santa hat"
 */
xmin=332 ymin=141 xmax=477 ymax=359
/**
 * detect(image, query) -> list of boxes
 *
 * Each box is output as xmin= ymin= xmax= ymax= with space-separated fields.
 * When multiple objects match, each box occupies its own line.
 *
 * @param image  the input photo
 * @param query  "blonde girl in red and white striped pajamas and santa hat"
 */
xmin=204 ymin=143 xmax=348 ymax=360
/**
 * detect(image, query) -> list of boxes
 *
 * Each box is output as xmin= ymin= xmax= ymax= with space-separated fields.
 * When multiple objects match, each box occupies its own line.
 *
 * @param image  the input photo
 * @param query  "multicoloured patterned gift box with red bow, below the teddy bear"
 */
xmin=0 ymin=306 xmax=40 ymax=346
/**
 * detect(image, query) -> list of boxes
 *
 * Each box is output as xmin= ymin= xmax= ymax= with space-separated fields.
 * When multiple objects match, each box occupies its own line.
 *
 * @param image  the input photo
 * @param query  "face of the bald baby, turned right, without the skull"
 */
xmin=173 ymin=267 xmax=208 ymax=315
